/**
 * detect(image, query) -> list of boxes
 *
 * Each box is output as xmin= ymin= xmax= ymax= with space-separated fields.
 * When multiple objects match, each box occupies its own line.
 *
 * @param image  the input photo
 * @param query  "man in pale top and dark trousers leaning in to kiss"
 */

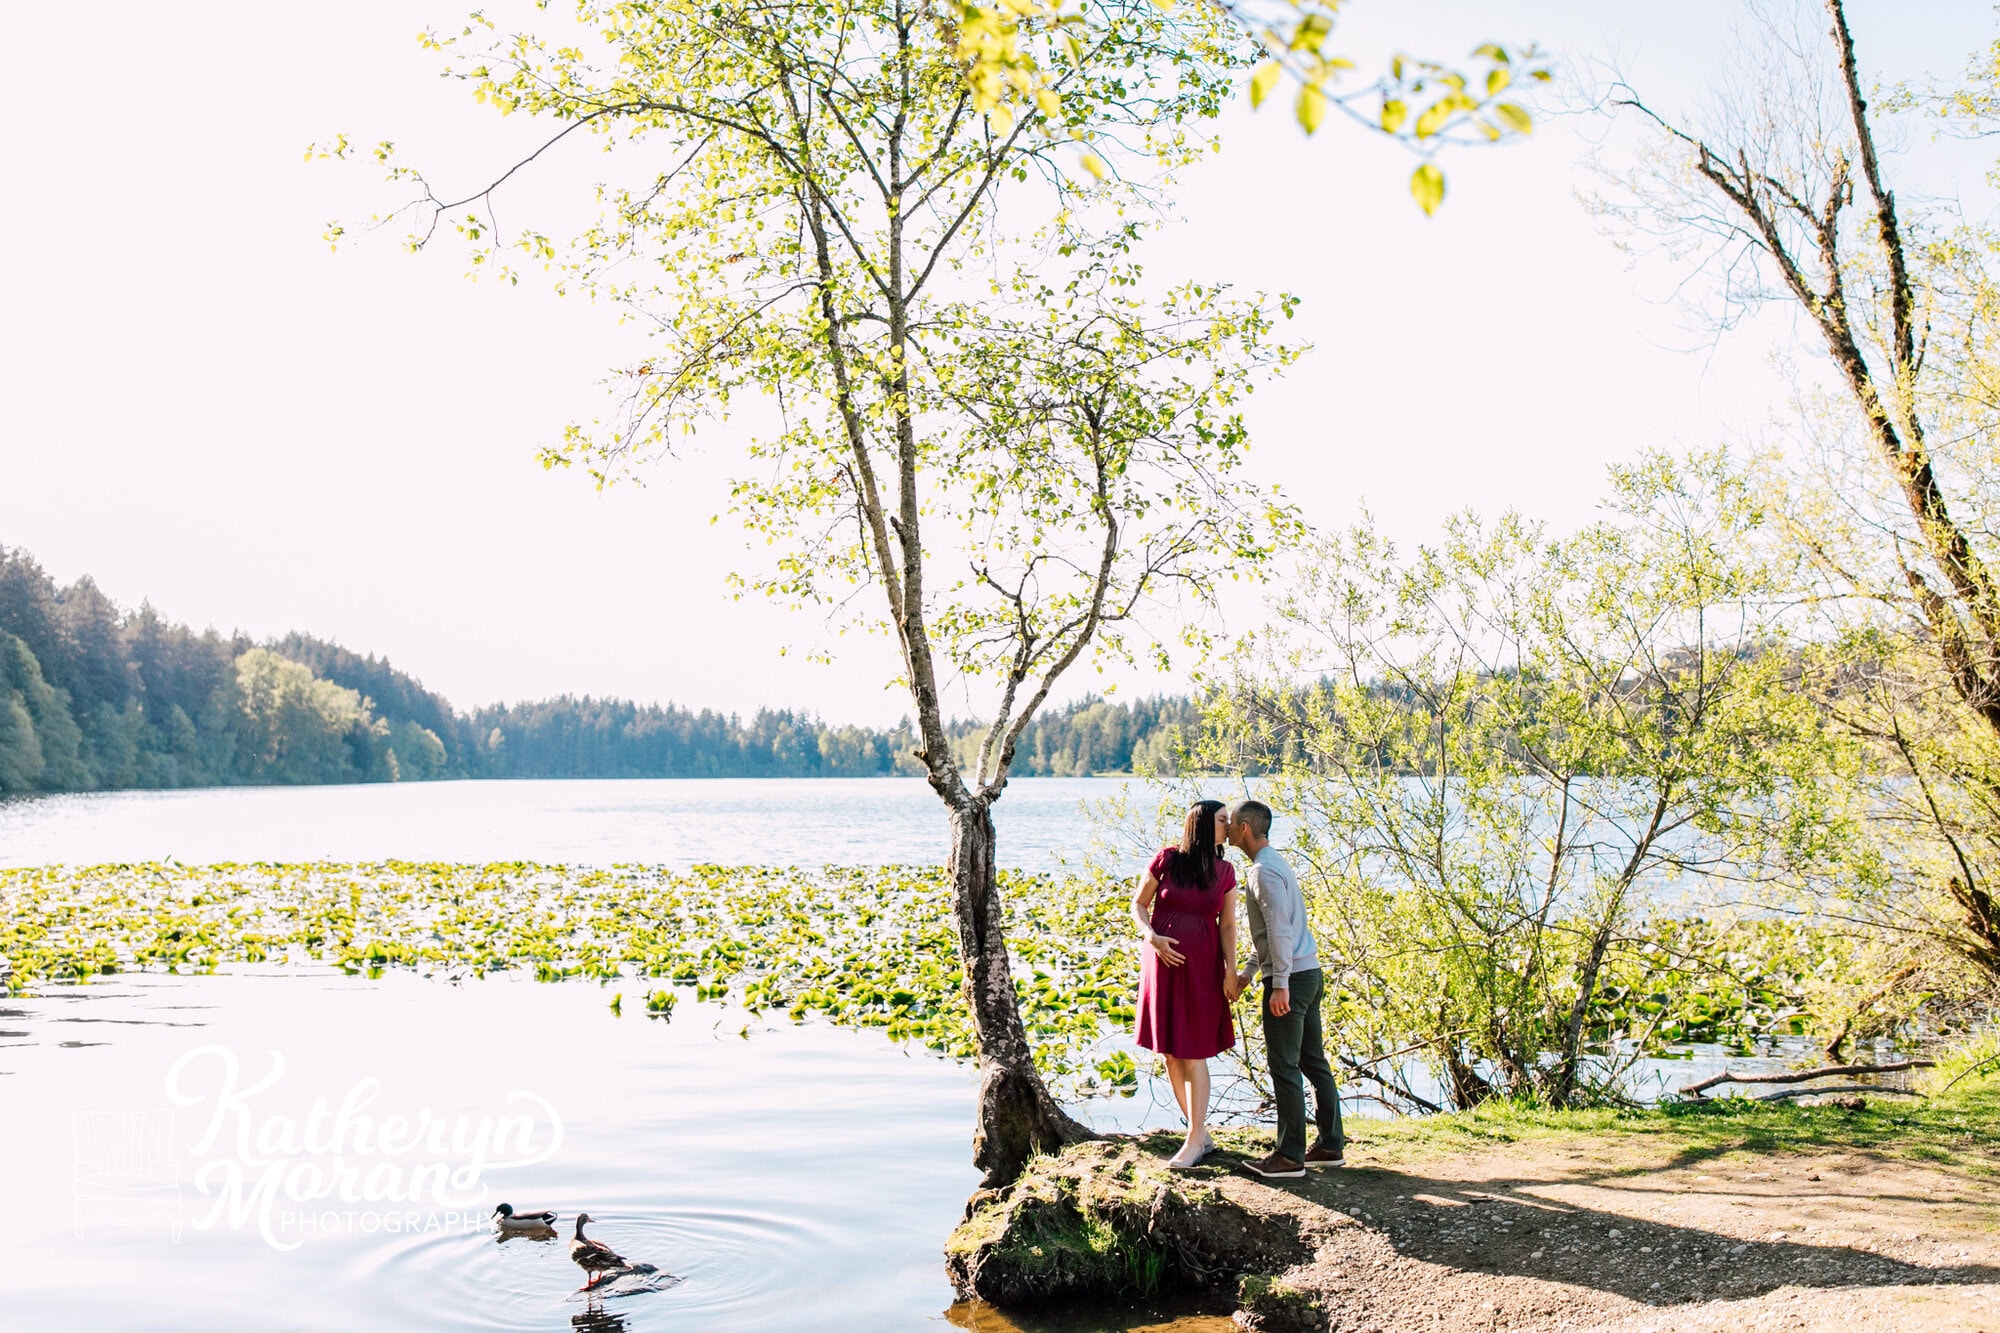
xmin=1226 ymin=801 xmax=1348 ymax=1179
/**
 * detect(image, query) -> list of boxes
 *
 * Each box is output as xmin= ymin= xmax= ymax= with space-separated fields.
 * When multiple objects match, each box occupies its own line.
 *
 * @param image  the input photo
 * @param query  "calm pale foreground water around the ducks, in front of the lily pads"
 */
xmin=0 ymin=969 xmax=978 ymax=1331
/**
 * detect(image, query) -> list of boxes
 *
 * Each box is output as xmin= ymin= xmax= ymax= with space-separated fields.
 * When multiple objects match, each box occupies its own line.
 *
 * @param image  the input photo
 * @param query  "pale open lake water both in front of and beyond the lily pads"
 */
xmin=0 ymin=779 xmax=1840 ymax=1333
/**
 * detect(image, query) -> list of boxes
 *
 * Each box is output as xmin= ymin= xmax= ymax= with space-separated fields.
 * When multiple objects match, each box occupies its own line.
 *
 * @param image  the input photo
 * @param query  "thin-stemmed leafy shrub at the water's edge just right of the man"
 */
xmin=1204 ymin=454 xmax=1844 ymax=1107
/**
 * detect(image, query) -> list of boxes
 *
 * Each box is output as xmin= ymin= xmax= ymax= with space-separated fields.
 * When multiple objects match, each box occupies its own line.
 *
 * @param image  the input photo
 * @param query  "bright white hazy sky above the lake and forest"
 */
xmin=0 ymin=0 xmax=2000 ymax=723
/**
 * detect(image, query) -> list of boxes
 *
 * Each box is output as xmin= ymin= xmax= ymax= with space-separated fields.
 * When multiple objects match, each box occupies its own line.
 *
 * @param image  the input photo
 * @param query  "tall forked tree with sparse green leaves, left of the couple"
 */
xmin=330 ymin=0 xmax=1290 ymax=1183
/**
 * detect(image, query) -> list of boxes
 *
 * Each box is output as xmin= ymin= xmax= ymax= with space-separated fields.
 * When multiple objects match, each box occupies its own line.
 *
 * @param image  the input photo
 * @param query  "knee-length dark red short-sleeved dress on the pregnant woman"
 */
xmin=1134 ymin=849 xmax=1236 ymax=1061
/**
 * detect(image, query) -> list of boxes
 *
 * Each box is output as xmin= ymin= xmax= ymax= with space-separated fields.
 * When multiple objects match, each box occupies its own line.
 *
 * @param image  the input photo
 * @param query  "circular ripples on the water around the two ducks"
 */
xmin=366 ymin=1207 xmax=844 ymax=1333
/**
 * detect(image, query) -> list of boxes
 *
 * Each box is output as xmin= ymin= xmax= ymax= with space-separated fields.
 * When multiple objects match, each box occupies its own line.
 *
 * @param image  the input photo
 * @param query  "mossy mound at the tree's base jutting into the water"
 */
xmin=944 ymin=1139 xmax=1348 ymax=1305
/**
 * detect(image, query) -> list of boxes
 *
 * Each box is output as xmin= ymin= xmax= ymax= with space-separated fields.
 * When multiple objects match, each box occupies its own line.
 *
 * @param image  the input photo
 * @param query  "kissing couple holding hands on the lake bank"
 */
xmin=1132 ymin=801 xmax=1346 ymax=1179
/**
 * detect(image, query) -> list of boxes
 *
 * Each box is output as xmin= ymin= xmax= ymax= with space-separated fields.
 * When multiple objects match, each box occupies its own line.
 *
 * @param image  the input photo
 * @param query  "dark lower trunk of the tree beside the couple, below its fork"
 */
xmin=950 ymin=799 xmax=1094 ymax=1189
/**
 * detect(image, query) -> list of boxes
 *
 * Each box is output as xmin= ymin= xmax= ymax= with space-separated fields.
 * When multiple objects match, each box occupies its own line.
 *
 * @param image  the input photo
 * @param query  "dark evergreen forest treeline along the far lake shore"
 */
xmin=0 ymin=546 xmax=1200 ymax=793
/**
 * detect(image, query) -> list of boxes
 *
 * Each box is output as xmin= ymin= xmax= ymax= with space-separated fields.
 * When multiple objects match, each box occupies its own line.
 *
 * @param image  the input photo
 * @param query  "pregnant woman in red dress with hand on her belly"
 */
xmin=1132 ymin=801 xmax=1236 ymax=1169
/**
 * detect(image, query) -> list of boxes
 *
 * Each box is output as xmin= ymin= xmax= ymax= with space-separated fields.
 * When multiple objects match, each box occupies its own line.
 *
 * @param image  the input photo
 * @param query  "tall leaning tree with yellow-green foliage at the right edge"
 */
xmin=1610 ymin=0 xmax=2000 ymax=975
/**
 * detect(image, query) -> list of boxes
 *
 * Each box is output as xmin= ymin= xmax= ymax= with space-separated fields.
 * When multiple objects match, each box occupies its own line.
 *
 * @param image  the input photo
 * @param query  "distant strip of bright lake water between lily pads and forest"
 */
xmin=0 ymin=779 xmax=1128 ymax=871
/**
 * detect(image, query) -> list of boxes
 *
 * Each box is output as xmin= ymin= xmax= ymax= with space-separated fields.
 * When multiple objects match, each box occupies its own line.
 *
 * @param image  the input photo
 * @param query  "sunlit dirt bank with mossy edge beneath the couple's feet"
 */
xmin=946 ymin=1079 xmax=2000 ymax=1333
